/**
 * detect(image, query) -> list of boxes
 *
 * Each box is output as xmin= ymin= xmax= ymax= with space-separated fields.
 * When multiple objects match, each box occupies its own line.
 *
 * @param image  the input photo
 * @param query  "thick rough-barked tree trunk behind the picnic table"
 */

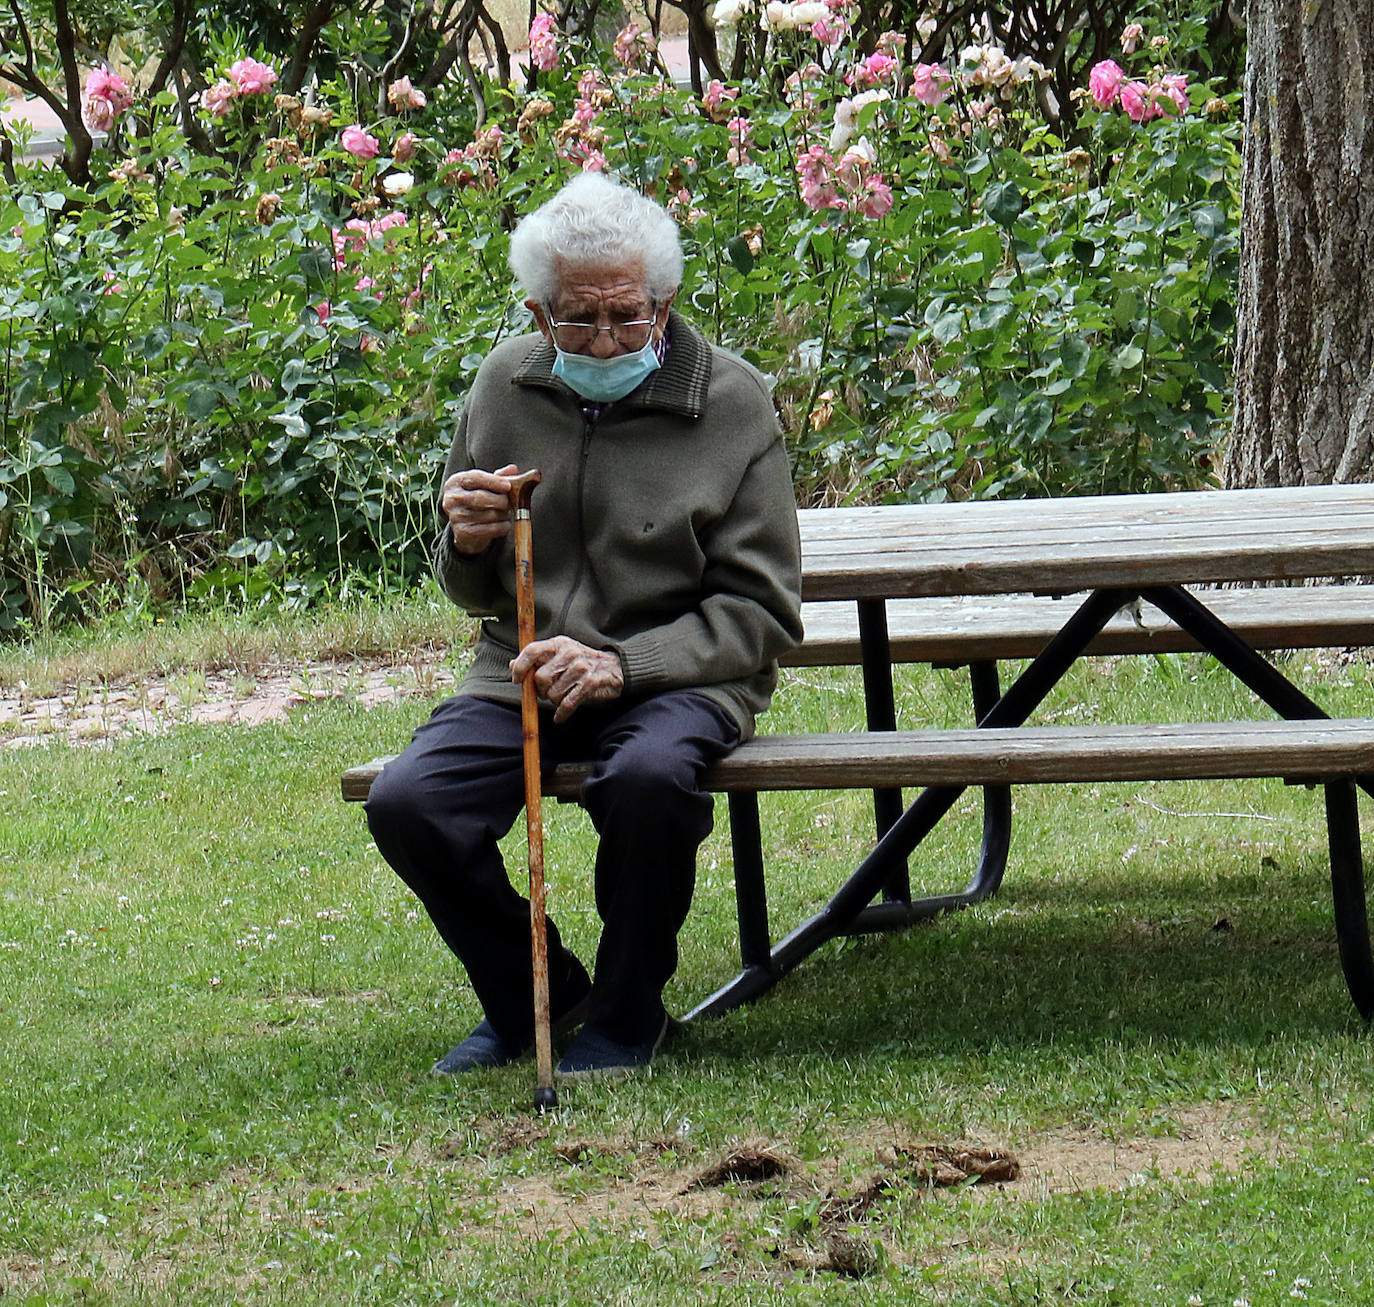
xmin=1223 ymin=0 xmax=1374 ymax=487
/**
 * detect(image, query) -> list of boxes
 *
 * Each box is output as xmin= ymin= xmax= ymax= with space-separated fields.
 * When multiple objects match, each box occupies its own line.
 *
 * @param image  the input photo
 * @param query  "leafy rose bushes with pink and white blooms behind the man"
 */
xmin=0 ymin=11 xmax=1238 ymax=625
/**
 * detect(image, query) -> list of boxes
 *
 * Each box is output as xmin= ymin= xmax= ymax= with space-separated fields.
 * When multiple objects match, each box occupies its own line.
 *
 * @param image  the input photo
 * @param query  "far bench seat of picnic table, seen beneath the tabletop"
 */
xmin=782 ymin=585 xmax=1374 ymax=667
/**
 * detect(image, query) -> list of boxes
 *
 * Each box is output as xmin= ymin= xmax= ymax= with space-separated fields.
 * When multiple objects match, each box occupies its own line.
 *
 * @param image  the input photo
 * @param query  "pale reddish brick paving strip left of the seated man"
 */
xmin=0 ymin=656 xmax=453 ymax=748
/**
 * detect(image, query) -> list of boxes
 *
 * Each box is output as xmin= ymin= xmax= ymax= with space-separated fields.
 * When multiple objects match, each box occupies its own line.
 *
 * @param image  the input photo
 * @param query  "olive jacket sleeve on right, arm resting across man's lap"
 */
xmin=611 ymin=437 xmax=802 ymax=694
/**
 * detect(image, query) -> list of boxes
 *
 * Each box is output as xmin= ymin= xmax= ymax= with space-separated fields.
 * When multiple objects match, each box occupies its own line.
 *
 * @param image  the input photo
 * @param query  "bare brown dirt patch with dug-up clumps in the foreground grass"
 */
xmin=0 ymin=1104 xmax=1282 ymax=1291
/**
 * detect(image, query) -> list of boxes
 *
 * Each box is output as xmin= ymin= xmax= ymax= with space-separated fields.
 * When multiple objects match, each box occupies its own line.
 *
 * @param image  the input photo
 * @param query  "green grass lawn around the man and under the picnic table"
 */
xmin=0 ymin=618 xmax=1374 ymax=1307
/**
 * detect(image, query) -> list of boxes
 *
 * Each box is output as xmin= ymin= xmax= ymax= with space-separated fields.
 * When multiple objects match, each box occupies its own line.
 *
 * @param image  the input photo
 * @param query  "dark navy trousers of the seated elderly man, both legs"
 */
xmin=367 ymin=691 xmax=738 ymax=1045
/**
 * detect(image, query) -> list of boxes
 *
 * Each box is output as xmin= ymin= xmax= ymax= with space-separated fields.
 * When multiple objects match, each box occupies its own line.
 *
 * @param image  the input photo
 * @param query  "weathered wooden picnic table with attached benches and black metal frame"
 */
xmin=344 ymin=485 xmax=1374 ymax=1018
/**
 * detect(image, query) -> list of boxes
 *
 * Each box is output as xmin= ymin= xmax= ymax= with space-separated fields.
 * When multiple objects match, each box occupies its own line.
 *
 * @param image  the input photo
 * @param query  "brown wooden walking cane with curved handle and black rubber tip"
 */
xmin=510 ymin=467 xmax=558 ymax=1112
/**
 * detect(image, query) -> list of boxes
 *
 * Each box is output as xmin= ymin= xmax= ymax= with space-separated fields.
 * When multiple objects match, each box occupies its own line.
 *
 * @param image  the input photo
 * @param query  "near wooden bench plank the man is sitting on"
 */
xmin=342 ymin=717 xmax=1374 ymax=801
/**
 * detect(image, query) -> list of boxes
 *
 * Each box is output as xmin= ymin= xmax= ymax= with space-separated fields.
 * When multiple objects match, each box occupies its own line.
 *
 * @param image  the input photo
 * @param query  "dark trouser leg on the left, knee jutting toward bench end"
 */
xmin=365 ymin=695 xmax=585 ymax=1046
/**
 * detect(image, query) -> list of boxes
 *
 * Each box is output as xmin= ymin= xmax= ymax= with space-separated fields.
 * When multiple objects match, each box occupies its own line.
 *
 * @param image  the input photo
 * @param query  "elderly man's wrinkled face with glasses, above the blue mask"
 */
xmin=525 ymin=262 xmax=672 ymax=359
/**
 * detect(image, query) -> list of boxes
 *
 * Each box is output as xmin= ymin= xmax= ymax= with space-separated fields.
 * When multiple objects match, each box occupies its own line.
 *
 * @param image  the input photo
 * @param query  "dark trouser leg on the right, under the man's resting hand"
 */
xmin=581 ymin=693 xmax=738 ymax=1043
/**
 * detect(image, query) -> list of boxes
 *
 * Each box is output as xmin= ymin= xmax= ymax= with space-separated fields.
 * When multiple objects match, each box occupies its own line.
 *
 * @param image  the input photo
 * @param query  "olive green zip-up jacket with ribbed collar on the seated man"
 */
xmin=434 ymin=312 xmax=801 ymax=739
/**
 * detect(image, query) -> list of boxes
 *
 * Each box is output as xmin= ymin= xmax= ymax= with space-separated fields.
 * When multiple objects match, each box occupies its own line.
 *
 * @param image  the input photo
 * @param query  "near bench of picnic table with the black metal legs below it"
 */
xmin=344 ymin=717 xmax=1374 ymax=1020
